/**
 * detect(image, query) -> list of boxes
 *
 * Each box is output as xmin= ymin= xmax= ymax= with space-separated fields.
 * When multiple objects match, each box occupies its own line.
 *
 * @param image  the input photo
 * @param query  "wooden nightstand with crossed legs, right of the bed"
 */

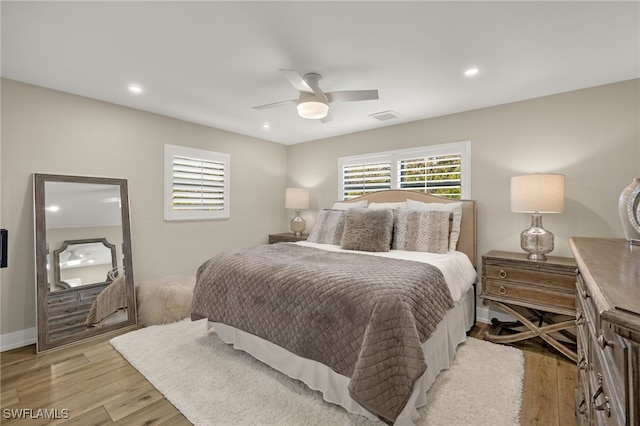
xmin=480 ymin=251 xmax=577 ymax=362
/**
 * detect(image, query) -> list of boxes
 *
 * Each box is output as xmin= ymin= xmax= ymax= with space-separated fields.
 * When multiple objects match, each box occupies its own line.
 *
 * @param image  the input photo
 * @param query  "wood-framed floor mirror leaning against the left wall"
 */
xmin=33 ymin=173 xmax=136 ymax=352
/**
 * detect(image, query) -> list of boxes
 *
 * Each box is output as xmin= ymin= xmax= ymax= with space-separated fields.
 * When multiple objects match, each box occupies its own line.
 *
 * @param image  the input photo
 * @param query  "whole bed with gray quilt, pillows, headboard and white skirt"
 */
xmin=191 ymin=190 xmax=477 ymax=425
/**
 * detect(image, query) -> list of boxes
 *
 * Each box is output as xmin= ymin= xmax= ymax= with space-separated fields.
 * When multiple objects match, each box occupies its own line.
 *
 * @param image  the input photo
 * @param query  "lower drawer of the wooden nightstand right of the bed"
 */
xmin=482 ymin=278 xmax=576 ymax=315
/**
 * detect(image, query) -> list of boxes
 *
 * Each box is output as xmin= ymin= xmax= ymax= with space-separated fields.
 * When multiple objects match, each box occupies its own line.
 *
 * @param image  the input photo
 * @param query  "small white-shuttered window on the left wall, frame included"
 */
xmin=164 ymin=145 xmax=230 ymax=220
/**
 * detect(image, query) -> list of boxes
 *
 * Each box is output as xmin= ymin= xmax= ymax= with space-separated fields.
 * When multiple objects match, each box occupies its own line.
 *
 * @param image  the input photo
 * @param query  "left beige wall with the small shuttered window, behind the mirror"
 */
xmin=0 ymin=79 xmax=288 ymax=346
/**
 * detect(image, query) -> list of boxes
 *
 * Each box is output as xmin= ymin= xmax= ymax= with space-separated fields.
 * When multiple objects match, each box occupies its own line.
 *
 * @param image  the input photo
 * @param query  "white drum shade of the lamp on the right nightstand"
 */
xmin=511 ymin=174 xmax=564 ymax=213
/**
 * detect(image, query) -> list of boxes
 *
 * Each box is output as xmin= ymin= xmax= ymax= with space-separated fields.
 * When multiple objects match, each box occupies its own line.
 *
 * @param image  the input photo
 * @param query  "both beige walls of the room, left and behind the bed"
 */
xmin=0 ymin=80 xmax=640 ymax=346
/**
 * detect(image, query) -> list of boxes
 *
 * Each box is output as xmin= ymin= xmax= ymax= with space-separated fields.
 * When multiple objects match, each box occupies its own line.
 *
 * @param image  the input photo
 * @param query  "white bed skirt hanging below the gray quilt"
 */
xmin=209 ymin=287 xmax=475 ymax=425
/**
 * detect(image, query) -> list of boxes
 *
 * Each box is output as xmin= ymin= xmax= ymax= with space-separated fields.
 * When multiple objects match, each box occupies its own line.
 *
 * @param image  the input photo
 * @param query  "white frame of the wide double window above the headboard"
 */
xmin=338 ymin=141 xmax=471 ymax=200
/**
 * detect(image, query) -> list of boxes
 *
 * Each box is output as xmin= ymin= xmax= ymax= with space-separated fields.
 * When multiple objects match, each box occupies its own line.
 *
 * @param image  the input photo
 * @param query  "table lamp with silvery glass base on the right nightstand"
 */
xmin=511 ymin=174 xmax=564 ymax=260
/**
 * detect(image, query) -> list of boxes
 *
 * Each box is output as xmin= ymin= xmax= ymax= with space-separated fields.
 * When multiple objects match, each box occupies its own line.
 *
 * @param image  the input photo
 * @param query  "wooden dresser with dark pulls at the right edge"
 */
xmin=569 ymin=237 xmax=640 ymax=425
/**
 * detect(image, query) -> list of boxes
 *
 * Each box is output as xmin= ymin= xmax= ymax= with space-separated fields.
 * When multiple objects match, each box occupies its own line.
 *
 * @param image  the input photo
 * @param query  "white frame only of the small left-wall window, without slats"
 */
xmin=164 ymin=144 xmax=231 ymax=221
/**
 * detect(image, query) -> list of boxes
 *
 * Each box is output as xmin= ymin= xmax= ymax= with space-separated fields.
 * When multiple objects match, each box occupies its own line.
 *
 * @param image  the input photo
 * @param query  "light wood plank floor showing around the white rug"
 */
xmin=0 ymin=323 xmax=577 ymax=426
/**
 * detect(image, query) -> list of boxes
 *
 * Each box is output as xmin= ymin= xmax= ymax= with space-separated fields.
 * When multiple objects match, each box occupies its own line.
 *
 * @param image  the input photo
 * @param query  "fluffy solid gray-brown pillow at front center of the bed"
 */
xmin=340 ymin=209 xmax=393 ymax=251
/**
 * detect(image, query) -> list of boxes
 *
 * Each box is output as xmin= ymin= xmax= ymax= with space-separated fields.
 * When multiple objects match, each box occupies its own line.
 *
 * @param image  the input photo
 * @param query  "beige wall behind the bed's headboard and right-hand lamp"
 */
xmin=288 ymin=80 xmax=640 ymax=262
